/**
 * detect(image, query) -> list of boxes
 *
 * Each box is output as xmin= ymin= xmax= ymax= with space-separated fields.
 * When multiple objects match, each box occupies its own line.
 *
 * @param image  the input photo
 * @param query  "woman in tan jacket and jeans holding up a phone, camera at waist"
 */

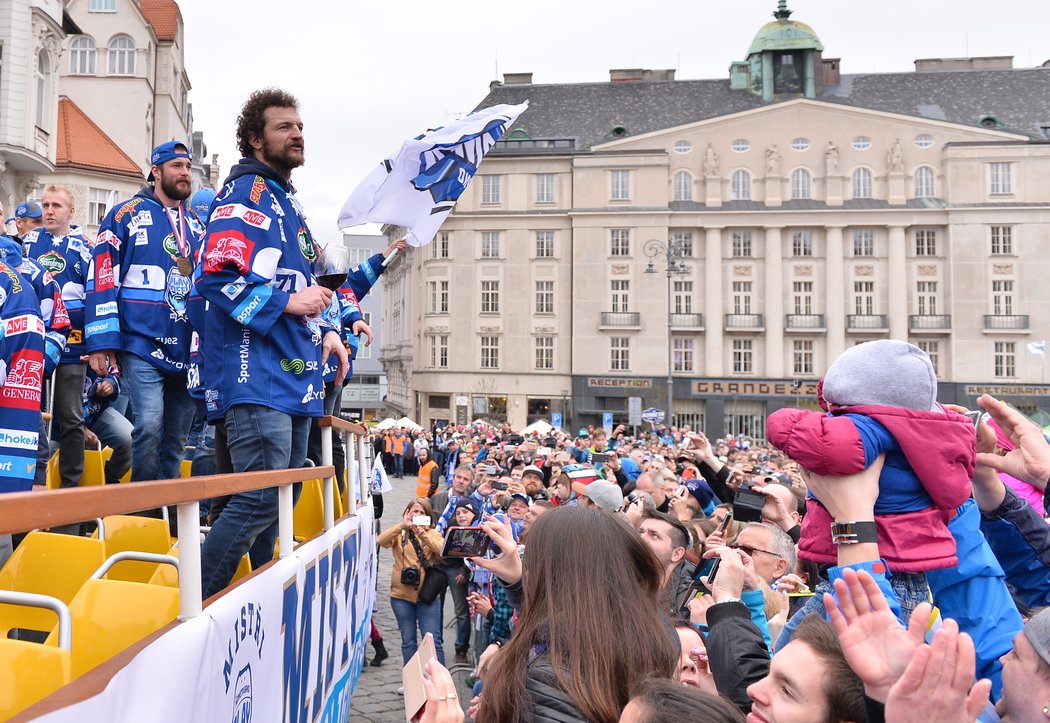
xmin=376 ymin=497 xmax=445 ymax=664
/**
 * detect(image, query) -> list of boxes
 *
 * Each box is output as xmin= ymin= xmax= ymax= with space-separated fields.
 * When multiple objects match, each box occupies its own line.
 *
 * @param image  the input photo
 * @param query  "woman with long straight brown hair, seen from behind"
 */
xmin=477 ymin=507 xmax=678 ymax=723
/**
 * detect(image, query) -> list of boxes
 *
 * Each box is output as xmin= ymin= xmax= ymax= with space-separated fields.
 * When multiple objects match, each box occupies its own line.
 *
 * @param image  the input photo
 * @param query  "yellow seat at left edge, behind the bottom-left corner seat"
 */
xmin=0 ymin=531 xmax=106 ymax=638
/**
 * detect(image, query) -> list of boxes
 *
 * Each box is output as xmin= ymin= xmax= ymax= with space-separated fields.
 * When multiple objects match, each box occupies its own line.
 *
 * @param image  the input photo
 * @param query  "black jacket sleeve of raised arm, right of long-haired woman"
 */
xmin=707 ymin=602 xmax=770 ymax=713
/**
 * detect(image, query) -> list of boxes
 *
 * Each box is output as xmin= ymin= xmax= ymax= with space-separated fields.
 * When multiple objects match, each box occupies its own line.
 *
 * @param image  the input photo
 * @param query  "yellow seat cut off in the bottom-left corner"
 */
xmin=0 ymin=639 xmax=72 ymax=721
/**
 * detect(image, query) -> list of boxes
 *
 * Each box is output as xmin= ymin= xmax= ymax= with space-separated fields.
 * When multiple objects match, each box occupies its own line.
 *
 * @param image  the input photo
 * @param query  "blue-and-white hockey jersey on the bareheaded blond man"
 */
xmin=22 ymin=226 xmax=91 ymax=364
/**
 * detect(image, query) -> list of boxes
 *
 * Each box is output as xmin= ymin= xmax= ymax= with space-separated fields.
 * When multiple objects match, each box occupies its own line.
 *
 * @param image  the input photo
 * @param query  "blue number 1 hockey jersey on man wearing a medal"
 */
xmin=85 ymin=186 xmax=204 ymax=374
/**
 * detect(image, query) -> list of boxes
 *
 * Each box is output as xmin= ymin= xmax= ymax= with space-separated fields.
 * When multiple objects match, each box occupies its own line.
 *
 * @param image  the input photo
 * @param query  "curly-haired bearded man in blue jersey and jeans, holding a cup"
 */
xmin=196 ymin=89 xmax=348 ymax=597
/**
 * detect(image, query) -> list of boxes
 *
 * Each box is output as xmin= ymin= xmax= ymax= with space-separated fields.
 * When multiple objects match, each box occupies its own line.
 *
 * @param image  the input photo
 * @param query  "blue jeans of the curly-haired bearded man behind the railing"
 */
xmin=201 ymin=404 xmax=310 ymax=598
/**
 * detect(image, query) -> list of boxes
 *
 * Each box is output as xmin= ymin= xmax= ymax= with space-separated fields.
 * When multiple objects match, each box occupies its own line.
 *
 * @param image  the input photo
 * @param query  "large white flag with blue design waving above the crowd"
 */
xmin=339 ymin=102 xmax=528 ymax=246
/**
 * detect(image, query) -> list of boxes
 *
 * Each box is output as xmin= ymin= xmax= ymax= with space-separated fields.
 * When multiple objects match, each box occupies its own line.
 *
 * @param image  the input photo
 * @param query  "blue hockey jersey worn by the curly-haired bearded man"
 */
xmin=196 ymin=158 xmax=324 ymax=421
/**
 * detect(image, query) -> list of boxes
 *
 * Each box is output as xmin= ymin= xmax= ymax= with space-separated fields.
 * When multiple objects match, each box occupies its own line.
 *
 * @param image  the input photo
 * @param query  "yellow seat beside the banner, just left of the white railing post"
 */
xmin=44 ymin=575 xmax=179 ymax=679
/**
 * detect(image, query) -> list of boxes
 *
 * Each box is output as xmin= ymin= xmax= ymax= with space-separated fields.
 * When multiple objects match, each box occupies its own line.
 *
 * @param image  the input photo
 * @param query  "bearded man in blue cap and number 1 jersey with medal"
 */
xmin=85 ymin=141 xmax=204 ymax=482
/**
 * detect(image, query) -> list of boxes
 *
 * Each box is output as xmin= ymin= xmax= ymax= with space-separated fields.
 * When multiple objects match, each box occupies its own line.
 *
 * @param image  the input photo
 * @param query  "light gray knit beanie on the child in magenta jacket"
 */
xmin=822 ymin=339 xmax=939 ymax=411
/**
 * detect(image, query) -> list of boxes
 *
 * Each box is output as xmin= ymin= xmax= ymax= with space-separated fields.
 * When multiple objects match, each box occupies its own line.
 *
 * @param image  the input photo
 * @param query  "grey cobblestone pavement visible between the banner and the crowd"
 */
xmin=350 ymin=475 xmax=471 ymax=723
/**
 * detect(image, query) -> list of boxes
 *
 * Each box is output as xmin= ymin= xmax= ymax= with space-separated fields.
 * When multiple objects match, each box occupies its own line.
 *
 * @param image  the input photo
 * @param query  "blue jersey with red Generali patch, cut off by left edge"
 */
xmin=0 ymin=261 xmax=44 ymax=492
